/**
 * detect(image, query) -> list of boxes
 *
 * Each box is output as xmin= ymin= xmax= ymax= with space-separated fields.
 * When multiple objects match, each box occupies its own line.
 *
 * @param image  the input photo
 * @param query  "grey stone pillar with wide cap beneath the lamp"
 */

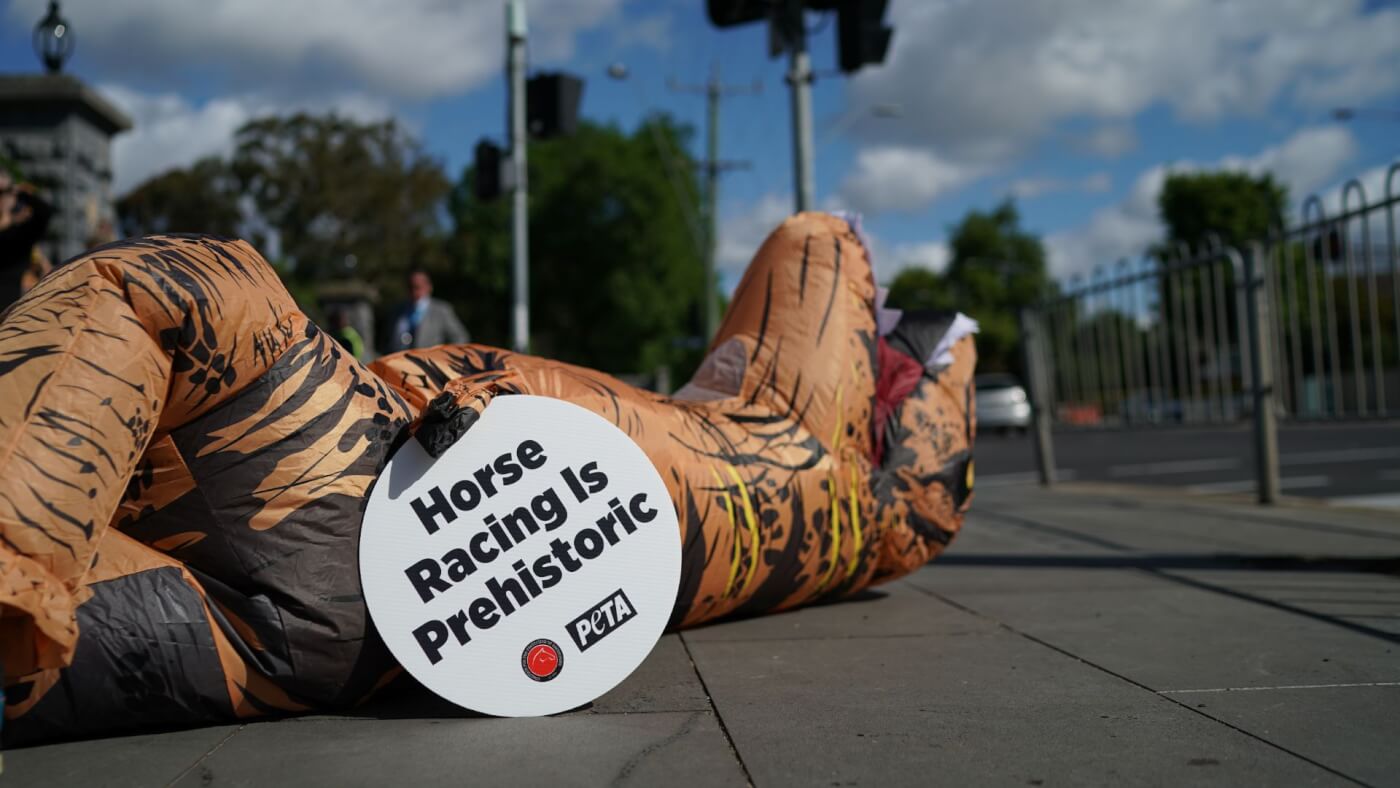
xmin=0 ymin=73 xmax=132 ymax=263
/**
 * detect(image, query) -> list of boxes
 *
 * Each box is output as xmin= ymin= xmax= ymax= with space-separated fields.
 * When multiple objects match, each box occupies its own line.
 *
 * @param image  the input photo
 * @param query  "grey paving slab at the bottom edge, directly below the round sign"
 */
xmin=176 ymin=711 xmax=745 ymax=788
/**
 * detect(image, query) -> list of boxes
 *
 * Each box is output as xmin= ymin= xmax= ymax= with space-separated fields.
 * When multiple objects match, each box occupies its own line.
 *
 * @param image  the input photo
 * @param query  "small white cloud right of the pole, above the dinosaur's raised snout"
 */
xmin=841 ymin=146 xmax=983 ymax=214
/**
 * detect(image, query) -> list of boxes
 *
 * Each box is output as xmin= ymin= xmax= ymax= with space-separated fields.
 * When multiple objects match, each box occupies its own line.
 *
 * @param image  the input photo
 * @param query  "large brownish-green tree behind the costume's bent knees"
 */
xmin=230 ymin=113 xmax=449 ymax=288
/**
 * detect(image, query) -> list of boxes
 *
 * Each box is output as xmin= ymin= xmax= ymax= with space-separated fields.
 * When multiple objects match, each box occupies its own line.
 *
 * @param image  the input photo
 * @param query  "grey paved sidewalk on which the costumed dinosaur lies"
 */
xmin=0 ymin=487 xmax=1400 ymax=788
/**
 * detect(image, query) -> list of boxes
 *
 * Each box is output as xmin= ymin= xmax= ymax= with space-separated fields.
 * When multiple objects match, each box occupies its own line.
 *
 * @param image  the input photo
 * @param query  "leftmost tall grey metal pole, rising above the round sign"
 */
xmin=505 ymin=0 xmax=529 ymax=353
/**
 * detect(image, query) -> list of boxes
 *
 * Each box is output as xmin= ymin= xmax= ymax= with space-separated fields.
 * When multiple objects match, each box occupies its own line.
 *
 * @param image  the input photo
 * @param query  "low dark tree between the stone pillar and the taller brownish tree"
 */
xmin=116 ymin=157 xmax=242 ymax=235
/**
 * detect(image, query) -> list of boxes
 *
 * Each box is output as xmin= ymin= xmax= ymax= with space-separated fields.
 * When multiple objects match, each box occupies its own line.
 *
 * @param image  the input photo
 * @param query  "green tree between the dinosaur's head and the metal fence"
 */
xmin=889 ymin=200 xmax=1050 ymax=371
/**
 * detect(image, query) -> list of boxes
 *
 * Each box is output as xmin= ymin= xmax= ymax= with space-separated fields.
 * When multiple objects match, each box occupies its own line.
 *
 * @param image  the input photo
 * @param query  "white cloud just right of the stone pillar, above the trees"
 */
xmin=101 ymin=85 xmax=389 ymax=195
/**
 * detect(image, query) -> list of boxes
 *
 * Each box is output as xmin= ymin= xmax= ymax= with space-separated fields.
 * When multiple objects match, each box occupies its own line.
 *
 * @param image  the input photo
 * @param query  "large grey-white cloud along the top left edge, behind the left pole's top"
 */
xmin=8 ymin=0 xmax=622 ymax=98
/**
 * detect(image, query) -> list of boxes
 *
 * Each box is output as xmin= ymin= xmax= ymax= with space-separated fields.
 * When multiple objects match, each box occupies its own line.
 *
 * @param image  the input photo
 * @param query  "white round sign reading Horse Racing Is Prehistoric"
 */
xmin=360 ymin=395 xmax=680 ymax=717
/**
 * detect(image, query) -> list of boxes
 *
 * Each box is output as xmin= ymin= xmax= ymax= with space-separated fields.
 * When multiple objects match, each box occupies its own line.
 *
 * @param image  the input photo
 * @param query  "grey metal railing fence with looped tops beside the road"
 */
xmin=1022 ymin=162 xmax=1400 ymax=500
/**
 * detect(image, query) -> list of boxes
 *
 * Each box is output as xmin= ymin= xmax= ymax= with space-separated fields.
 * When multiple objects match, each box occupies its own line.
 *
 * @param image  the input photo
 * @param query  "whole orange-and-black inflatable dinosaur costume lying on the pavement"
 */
xmin=0 ymin=214 xmax=974 ymax=743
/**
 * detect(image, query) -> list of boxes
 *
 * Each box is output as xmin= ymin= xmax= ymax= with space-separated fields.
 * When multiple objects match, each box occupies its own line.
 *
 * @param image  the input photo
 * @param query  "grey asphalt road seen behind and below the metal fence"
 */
xmin=976 ymin=421 xmax=1400 ymax=509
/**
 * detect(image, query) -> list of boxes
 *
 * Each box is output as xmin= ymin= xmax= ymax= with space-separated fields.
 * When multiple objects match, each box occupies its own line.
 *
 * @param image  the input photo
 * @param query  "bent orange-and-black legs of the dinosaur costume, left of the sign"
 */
xmin=0 ymin=237 xmax=409 ymax=739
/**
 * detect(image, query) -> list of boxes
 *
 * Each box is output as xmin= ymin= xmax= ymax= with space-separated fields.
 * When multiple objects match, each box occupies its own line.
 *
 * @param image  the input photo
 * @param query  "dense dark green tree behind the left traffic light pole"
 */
xmin=448 ymin=116 xmax=703 ymax=379
